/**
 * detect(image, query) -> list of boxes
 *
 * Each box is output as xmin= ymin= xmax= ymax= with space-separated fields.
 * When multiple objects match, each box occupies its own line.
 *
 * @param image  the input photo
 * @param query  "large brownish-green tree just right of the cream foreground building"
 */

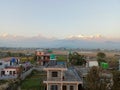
xmin=86 ymin=66 xmax=108 ymax=90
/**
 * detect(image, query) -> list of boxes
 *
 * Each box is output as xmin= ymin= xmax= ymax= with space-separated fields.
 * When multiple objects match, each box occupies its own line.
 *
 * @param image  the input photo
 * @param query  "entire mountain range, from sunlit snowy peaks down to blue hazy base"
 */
xmin=0 ymin=35 xmax=120 ymax=49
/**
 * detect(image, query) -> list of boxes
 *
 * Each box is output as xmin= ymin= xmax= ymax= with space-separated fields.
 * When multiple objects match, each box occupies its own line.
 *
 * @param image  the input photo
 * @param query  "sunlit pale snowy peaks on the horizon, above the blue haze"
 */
xmin=0 ymin=33 xmax=120 ymax=42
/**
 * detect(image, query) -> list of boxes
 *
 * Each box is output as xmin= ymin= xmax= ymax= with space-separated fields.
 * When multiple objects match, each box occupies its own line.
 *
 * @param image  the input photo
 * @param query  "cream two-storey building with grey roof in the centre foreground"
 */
xmin=43 ymin=60 xmax=82 ymax=90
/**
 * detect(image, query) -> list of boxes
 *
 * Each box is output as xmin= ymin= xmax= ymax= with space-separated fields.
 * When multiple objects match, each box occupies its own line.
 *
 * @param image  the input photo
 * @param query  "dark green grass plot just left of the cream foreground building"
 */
xmin=21 ymin=71 xmax=46 ymax=90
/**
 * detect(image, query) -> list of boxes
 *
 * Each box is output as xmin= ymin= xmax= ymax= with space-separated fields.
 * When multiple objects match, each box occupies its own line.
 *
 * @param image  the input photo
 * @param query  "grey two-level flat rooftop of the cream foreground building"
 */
xmin=44 ymin=61 xmax=82 ymax=83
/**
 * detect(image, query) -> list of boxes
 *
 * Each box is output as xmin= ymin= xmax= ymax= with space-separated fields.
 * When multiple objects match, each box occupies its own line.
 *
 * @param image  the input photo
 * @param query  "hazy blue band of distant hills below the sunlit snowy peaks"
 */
xmin=0 ymin=38 xmax=120 ymax=49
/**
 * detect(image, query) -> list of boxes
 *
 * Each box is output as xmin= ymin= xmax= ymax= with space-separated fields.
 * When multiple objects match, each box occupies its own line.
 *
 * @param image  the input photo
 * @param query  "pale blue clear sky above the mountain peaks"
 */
xmin=0 ymin=0 xmax=120 ymax=38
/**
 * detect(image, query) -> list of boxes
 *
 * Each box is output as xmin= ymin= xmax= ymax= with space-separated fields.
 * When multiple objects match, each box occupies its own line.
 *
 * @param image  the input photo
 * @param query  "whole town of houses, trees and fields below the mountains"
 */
xmin=0 ymin=48 xmax=120 ymax=90
